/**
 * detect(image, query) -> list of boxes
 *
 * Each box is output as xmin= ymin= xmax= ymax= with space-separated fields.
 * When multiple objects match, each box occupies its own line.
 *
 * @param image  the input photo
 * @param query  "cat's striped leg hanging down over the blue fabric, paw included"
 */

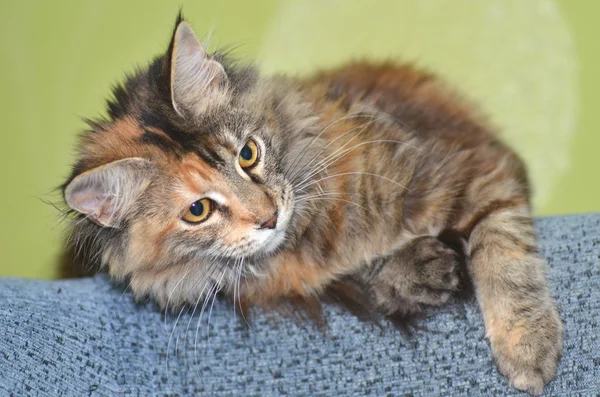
xmin=465 ymin=154 xmax=562 ymax=394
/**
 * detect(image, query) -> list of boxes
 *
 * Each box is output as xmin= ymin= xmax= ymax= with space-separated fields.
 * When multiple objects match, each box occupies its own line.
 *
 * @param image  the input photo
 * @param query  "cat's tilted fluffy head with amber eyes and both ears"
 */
xmin=64 ymin=20 xmax=314 ymax=290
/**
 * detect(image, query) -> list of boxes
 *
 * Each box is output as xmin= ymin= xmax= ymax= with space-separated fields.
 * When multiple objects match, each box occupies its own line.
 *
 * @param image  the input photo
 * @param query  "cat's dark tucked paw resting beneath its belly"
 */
xmin=359 ymin=236 xmax=459 ymax=314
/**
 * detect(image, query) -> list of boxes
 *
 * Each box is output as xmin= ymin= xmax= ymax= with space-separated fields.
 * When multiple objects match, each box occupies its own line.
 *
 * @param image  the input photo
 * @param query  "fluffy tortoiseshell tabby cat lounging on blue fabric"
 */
xmin=63 ymin=16 xmax=562 ymax=394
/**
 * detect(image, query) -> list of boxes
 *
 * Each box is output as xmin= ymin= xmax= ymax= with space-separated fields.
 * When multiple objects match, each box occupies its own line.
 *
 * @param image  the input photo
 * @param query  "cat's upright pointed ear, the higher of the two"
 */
xmin=170 ymin=21 xmax=228 ymax=117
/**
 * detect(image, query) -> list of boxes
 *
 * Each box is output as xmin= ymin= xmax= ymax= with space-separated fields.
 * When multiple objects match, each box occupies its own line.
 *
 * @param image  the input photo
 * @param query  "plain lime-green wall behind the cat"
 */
xmin=0 ymin=0 xmax=600 ymax=278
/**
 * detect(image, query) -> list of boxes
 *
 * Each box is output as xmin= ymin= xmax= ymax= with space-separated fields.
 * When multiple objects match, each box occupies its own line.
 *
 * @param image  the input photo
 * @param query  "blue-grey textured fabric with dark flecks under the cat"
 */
xmin=0 ymin=214 xmax=600 ymax=396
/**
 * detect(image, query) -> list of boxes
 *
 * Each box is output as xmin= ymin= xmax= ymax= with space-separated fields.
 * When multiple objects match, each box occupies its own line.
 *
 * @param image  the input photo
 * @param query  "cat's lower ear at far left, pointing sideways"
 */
xmin=64 ymin=157 xmax=156 ymax=228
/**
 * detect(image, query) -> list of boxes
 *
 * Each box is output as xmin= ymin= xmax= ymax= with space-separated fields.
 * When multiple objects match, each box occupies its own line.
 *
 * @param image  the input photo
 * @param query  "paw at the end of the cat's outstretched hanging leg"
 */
xmin=488 ymin=303 xmax=563 ymax=395
